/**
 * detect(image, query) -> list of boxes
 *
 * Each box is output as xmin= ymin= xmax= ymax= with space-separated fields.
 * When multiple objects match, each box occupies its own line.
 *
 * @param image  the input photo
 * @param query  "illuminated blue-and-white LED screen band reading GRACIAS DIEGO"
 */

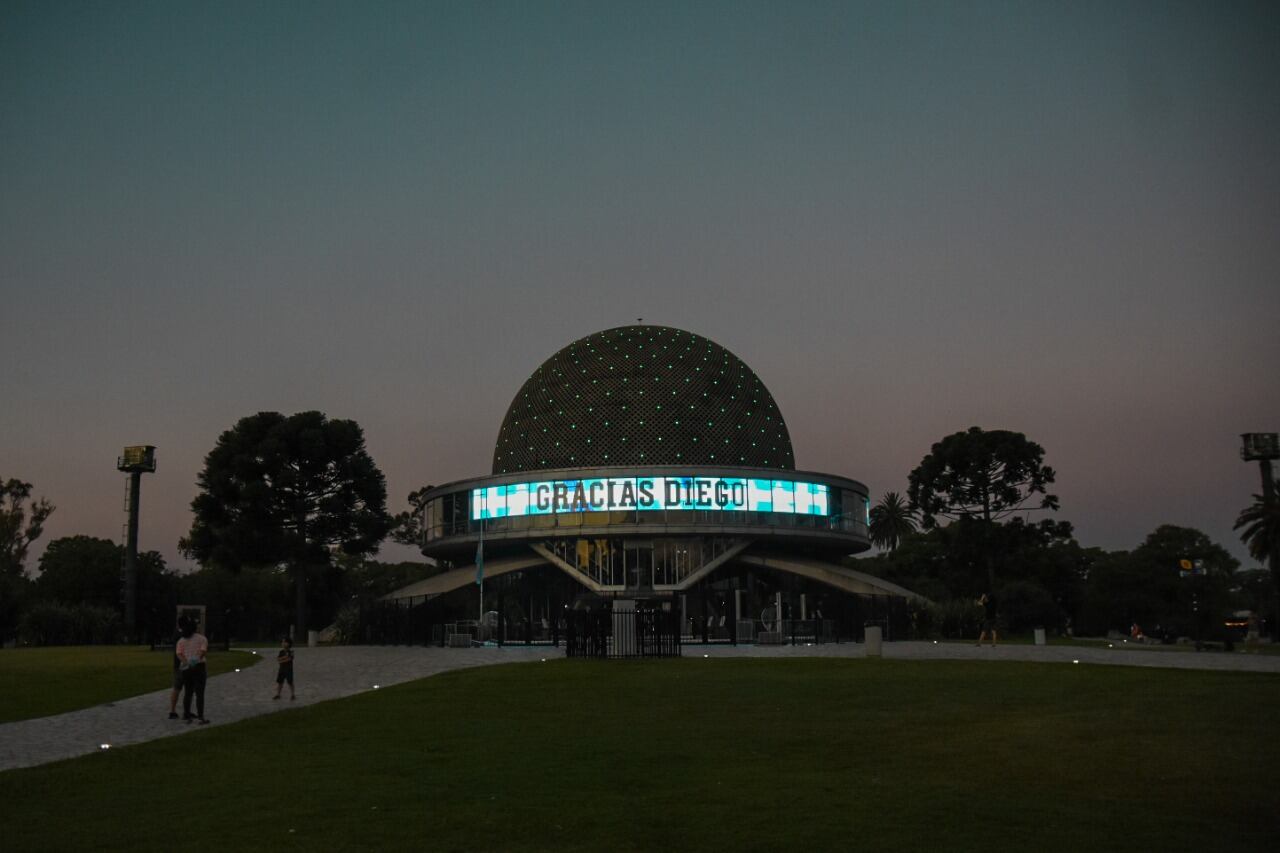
xmin=471 ymin=476 xmax=831 ymax=520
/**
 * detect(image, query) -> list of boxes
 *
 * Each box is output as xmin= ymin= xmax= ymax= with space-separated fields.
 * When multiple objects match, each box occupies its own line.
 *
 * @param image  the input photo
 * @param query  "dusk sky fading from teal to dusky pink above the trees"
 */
xmin=0 ymin=0 xmax=1280 ymax=569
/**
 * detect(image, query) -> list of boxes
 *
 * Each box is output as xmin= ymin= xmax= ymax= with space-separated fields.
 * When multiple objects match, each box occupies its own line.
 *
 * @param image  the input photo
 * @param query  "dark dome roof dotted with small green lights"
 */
xmin=493 ymin=325 xmax=795 ymax=474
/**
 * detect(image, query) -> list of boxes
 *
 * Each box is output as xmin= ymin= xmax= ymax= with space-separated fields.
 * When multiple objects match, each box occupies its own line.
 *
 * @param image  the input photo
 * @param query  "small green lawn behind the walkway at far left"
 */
xmin=0 ymin=646 xmax=262 ymax=722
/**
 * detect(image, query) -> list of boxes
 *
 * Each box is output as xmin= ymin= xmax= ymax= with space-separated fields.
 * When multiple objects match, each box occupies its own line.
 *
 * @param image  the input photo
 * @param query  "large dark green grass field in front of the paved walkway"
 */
xmin=0 ymin=658 xmax=1280 ymax=853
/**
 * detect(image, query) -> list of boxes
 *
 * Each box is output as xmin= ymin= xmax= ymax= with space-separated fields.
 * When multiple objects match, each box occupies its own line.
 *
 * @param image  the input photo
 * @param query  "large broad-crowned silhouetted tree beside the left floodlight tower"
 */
xmin=180 ymin=411 xmax=392 ymax=631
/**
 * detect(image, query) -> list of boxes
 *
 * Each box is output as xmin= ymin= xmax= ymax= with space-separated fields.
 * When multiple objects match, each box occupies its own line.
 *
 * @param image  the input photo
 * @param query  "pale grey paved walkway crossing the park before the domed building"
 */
xmin=0 ymin=642 xmax=1280 ymax=771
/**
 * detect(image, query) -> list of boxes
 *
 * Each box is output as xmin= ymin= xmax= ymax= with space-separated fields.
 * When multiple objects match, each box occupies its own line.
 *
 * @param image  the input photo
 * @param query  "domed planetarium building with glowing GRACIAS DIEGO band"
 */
xmin=379 ymin=325 xmax=915 ymax=653
